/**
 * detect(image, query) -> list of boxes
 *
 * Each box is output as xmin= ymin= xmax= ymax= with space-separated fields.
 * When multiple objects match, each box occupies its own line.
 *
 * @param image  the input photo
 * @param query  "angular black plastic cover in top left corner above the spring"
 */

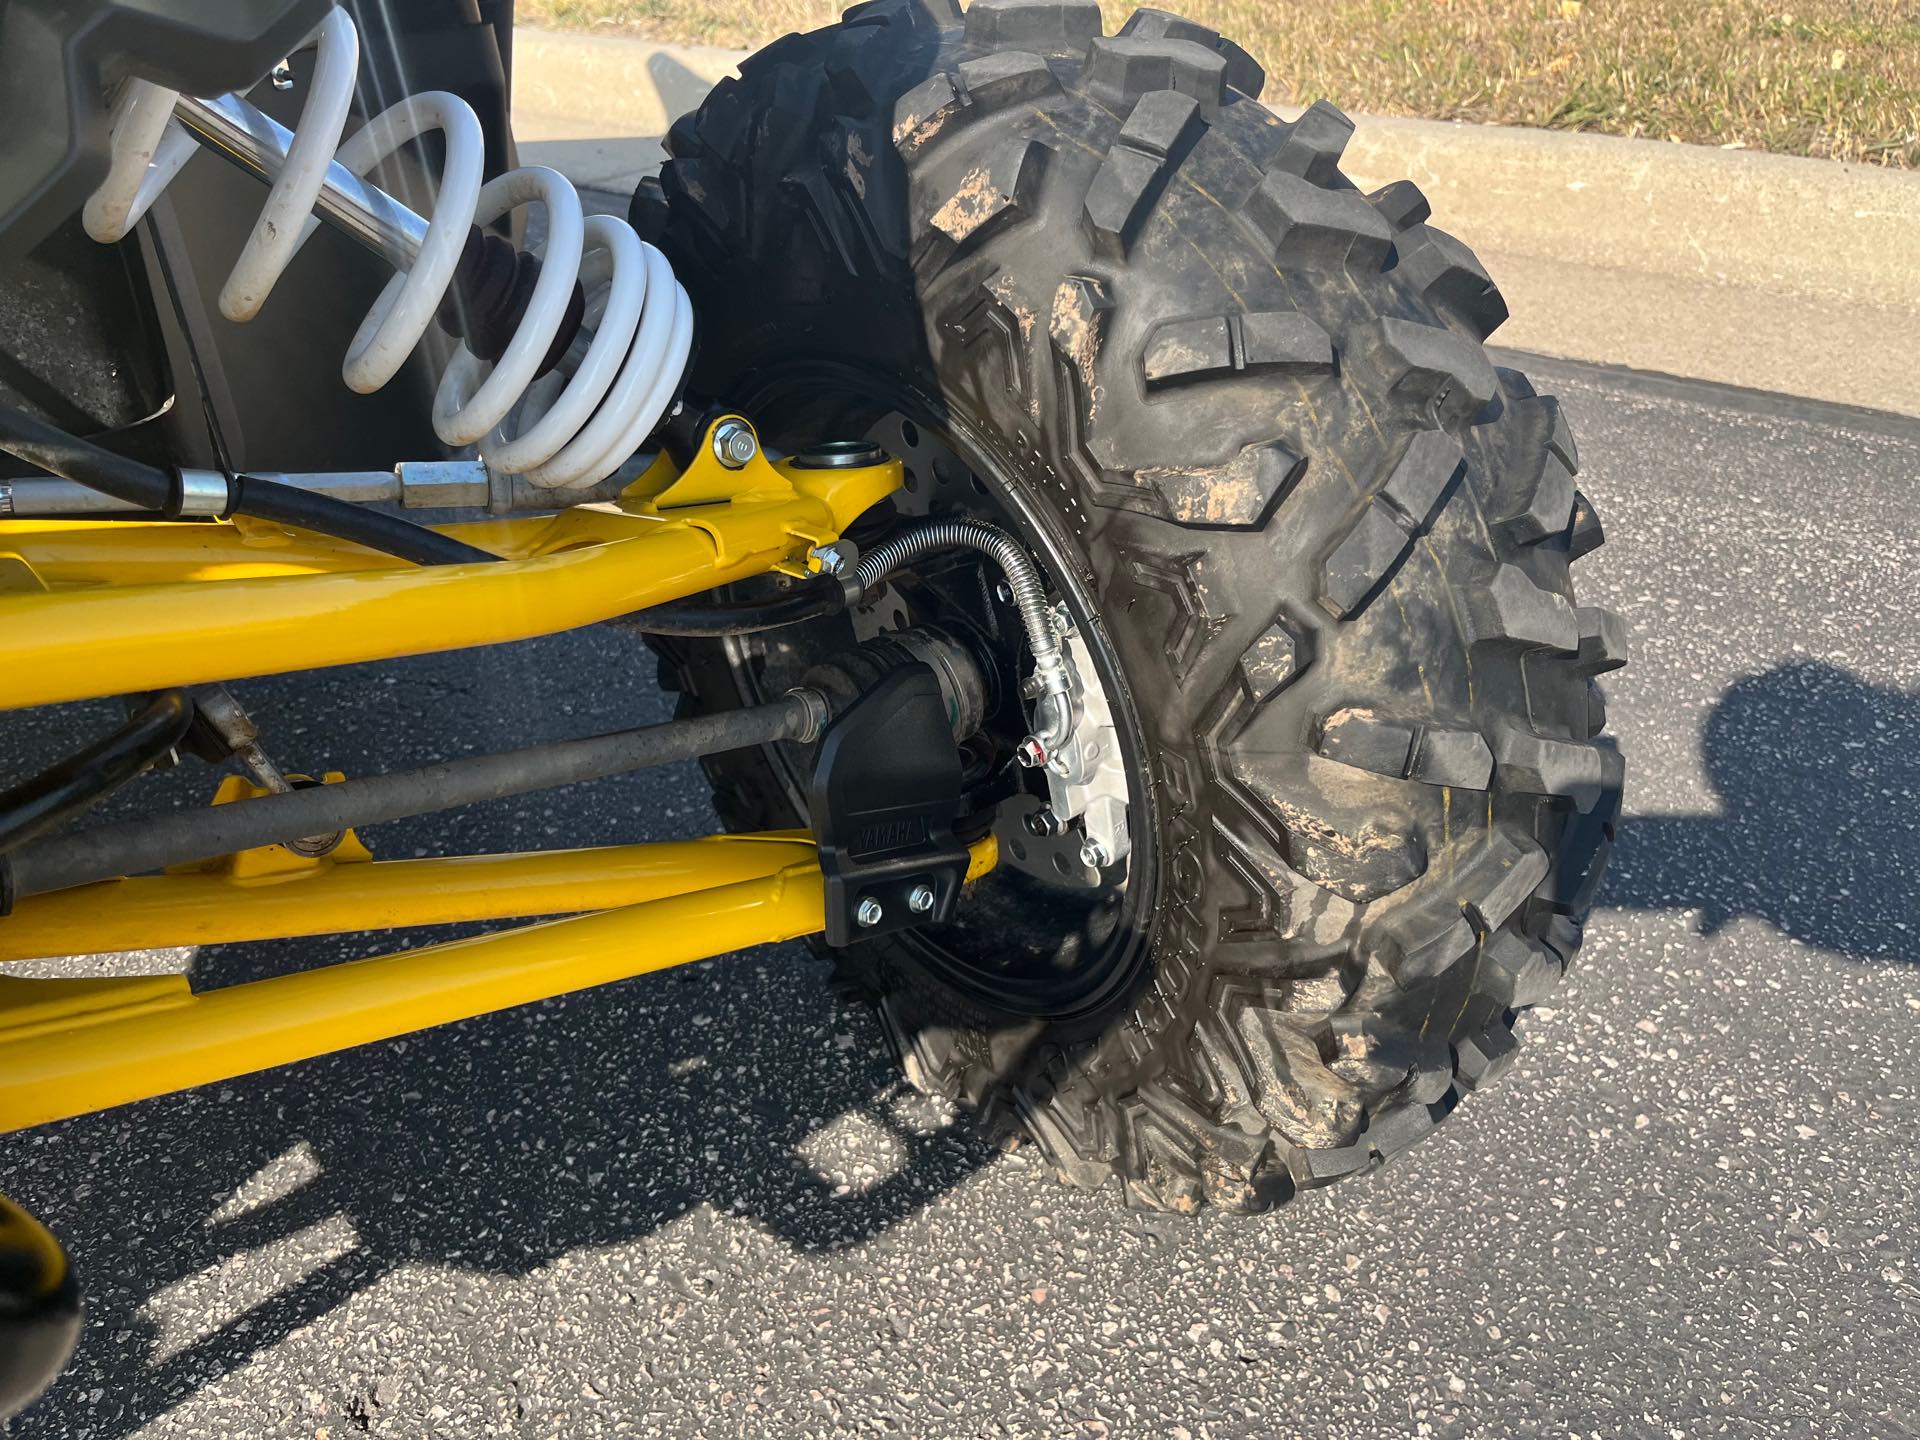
xmin=0 ymin=0 xmax=332 ymax=265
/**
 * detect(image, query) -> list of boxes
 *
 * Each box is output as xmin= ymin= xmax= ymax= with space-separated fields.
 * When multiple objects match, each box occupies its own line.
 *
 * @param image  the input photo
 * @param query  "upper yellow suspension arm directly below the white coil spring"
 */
xmin=0 ymin=459 xmax=900 ymax=708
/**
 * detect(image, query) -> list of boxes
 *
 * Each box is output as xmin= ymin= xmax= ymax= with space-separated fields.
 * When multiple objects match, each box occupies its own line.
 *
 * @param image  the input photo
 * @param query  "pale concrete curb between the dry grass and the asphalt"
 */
xmin=515 ymin=31 xmax=1920 ymax=415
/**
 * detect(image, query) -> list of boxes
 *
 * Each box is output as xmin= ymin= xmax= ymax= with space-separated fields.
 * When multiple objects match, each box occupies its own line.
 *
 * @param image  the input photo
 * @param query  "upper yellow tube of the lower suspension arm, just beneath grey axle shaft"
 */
xmin=0 ymin=831 xmax=814 ymax=963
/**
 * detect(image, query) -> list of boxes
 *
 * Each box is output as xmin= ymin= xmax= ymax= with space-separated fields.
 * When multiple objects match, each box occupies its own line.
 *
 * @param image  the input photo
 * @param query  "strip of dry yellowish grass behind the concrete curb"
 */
xmin=520 ymin=0 xmax=1920 ymax=167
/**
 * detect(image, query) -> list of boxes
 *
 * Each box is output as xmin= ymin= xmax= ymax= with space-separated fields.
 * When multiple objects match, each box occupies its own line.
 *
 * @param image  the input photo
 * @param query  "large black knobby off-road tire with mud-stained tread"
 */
xmin=634 ymin=0 xmax=1624 ymax=1212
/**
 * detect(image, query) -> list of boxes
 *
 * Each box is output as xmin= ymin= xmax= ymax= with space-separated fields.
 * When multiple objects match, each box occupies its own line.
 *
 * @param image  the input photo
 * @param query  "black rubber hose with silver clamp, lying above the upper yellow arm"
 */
xmin=0 ymin=405 xmax=499 ymax=564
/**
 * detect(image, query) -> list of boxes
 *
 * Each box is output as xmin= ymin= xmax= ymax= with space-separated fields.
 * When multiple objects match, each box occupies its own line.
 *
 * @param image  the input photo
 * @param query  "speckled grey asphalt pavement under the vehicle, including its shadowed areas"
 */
xmin=0 ymin=353 xmax=1920 ymax=1440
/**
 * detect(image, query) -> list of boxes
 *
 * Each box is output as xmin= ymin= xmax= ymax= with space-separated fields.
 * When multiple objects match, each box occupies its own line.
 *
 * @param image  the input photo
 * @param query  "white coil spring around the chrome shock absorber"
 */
xmin=83 ymin=10 xmax=693 ymax=488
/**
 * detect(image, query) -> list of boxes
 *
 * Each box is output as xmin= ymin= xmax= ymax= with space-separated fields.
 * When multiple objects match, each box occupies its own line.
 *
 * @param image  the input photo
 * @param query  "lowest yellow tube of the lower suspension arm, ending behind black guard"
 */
xmin=0 ymin=833 xmax=998 ymax=1133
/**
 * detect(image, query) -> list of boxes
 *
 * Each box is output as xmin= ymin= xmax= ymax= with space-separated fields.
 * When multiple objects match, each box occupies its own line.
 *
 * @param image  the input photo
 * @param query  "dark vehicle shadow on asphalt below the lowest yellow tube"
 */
xmin=0 ymin=945 xmax=995 ymax=1436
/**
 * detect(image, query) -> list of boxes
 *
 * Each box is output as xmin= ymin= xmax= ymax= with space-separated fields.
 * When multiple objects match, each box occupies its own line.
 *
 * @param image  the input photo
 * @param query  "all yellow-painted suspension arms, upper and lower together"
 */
xmin=0 ymin=416 xmax=993 ymax=1131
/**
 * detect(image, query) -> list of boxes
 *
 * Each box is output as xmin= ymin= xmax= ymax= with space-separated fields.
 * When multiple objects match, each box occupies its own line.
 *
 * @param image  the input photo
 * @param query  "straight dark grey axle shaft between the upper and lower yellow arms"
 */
xmin=0 ymin=691 xmax=828 ymax=900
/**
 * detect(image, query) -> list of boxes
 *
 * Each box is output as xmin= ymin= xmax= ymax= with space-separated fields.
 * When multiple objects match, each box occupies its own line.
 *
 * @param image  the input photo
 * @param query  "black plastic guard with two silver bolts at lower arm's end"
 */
xmin=806 ymin=660 xmax=968 ymax=947
